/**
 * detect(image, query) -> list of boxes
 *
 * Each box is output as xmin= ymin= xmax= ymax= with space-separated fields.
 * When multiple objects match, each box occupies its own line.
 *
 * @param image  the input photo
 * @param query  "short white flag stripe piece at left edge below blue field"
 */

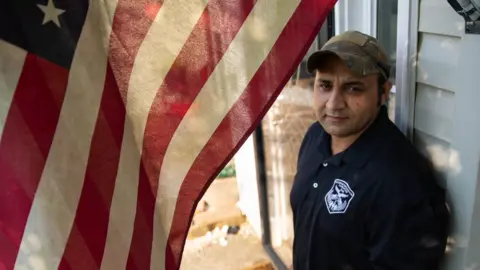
xmin=0 ymin=40 xmax=27 ymax=139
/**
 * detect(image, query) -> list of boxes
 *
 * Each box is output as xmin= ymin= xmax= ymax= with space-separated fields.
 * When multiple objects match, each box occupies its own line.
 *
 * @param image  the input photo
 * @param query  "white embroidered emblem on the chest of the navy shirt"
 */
xmin=325 ymin=179 xmax=355 ymax=214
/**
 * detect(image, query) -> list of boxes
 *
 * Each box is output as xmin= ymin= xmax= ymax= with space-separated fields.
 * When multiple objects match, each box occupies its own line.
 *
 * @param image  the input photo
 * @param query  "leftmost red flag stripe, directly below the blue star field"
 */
xmin=0 ymin=54 xmax=68 ymax=269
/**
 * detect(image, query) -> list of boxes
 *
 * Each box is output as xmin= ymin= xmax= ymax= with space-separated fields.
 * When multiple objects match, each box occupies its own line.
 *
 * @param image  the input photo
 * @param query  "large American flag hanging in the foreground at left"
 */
xmin=0 ymin=0 xmax=336 ymax=270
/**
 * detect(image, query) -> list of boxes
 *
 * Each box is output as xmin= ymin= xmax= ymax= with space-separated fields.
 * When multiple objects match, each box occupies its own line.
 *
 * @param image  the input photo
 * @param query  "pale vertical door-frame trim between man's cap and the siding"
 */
xmin=395 ymin=0 xmax=420 ymax=139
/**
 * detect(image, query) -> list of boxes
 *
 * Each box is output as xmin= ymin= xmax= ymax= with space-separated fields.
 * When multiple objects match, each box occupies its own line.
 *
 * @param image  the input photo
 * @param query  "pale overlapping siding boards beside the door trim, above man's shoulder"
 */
xmin=413 ymin=0 xmax=463 ymax=177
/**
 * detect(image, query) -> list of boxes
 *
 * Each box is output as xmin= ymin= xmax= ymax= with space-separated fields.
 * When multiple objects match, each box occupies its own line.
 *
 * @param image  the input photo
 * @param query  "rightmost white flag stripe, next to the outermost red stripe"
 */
xmin=151 ymin=0 xmax=300 ymax=270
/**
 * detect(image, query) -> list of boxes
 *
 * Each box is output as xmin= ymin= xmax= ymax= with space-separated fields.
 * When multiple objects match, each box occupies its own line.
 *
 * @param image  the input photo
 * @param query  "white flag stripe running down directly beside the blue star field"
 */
xmin=15 ymin=0 xmax=116 ymax=269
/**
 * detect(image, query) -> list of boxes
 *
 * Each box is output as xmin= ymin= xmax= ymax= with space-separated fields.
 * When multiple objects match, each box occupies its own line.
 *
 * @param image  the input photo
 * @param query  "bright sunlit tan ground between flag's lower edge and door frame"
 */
xmin=180 ymin=178 xmax=274 ymax=270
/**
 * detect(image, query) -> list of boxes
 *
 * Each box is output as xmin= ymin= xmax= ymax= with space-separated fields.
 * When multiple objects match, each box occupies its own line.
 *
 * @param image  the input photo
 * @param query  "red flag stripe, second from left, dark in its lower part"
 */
xmin=59 ymin=0 xmax=161 ymax=270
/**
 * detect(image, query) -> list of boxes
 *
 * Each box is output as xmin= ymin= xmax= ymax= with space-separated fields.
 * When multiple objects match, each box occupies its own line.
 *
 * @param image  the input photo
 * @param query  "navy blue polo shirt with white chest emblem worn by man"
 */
xmin=290 ymin=107 xmax=448 ymax=270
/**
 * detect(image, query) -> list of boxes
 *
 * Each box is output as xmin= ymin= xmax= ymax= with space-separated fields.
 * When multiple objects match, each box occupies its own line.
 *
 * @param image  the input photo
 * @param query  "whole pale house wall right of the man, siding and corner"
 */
xmin=412 ymin=0 xmax=480 ymax=270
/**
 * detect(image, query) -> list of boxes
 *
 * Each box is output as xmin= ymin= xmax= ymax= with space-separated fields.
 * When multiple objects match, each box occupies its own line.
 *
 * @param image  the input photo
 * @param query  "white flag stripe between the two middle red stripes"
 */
xmin=101 ymin=0 xmax=207 ymax=270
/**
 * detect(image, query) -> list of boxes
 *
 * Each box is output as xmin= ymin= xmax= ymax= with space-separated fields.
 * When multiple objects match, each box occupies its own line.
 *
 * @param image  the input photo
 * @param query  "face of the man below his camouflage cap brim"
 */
xmin=314 ymin=55 xmax=389 ymax=138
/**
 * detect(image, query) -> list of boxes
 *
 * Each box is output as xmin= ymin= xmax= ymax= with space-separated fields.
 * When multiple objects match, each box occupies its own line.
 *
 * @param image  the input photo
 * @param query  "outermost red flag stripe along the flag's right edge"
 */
xmin=165 ymin=0 xmax=336 ymax=270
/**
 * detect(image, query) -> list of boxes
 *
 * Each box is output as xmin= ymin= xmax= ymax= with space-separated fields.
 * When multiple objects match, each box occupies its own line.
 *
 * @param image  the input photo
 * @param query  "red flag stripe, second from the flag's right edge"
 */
xmin=127 ymin=0 xmax=255 ymax=270
